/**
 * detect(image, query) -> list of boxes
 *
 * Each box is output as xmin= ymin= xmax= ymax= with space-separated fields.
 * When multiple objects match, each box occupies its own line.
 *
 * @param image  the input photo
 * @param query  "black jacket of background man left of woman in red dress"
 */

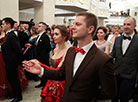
xmin=36 ymin=33 xmax=51 ymax=65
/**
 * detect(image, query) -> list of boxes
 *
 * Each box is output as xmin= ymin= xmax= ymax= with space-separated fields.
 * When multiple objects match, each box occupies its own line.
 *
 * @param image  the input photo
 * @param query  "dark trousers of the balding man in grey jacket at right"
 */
xmin=112 ymin=75 xmax=135 ymax=102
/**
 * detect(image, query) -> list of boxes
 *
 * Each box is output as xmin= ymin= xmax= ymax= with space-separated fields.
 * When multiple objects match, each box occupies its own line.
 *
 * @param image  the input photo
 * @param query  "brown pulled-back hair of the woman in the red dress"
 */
xmin=55 ymin=25 xmax=69 ymax=41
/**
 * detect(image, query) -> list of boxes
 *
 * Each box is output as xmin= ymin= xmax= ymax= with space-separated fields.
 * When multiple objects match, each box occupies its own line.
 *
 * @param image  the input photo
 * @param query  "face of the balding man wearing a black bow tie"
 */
xmin=124 ymin=18 xmax=135 ymax=35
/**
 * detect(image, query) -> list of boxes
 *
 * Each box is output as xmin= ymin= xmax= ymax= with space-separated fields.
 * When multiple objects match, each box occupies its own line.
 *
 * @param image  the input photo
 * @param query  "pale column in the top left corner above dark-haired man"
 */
xmin=0 ymin=0 xmax=19 ymax=21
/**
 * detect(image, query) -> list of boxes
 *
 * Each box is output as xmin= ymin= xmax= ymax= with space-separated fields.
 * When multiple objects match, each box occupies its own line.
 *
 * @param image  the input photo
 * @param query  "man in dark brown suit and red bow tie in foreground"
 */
xmin=23 ymin=12 xmax=116 ymax=102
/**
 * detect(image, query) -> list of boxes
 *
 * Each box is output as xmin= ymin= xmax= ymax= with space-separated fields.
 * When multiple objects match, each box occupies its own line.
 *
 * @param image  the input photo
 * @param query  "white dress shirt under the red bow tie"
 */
xmin=73 ymin=42 xmax=94 ymax=76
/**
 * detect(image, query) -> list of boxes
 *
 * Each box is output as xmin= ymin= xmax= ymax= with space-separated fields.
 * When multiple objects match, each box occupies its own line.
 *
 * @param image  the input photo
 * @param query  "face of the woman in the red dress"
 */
xmin=53 ymin=28 xmax=65 ymax=44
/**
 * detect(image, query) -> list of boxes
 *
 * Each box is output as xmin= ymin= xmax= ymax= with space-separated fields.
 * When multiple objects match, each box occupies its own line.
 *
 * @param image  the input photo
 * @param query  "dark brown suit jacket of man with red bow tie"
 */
xmin=42 ymin=45 xmax=116 ymax=102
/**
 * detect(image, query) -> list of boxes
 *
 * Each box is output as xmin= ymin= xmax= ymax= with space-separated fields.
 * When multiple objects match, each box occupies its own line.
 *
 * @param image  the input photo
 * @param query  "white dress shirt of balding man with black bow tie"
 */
xmin=122 ymin=33 xmax=135 ymax=54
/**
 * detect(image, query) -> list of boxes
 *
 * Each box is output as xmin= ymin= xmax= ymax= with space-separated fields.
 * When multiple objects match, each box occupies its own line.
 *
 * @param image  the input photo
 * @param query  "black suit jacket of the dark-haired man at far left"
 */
xmin=1 ymin=31 xmax=22 ymax=75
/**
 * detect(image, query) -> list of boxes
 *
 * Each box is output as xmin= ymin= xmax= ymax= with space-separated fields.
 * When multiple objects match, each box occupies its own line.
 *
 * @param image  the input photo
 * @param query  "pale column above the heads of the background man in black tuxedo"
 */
xmin=34 ymin=0 xmax=55 ymax=26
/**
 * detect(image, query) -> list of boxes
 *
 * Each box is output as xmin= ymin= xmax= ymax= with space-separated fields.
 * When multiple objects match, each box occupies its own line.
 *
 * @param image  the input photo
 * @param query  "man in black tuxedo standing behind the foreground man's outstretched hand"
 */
xmin=35 ymin=22 xmax=51 ymax=88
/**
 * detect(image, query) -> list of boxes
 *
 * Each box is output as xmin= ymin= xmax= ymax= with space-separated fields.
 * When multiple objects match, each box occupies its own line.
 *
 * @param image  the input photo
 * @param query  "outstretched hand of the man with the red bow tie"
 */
xmin=22 ymin=60 xmax=41 ymax=74
